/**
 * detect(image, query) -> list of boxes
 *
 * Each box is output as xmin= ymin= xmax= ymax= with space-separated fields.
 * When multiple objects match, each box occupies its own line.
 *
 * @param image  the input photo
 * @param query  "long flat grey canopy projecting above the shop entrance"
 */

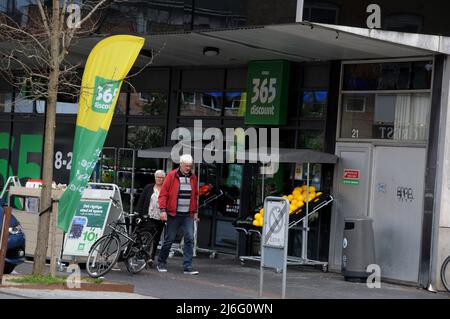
xmin=75 ymin=22 xmax=450 ymax=66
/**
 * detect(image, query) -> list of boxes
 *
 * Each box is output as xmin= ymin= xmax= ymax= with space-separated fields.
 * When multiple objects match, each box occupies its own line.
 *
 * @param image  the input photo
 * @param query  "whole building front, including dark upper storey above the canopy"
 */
xmin=0 ymin=0 xmax=450 ymax=287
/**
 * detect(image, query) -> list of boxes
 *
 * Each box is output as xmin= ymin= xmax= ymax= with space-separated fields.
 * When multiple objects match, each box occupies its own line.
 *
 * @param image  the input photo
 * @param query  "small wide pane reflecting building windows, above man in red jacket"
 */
xmin=180 ymin=92 xmax=223 ymax=116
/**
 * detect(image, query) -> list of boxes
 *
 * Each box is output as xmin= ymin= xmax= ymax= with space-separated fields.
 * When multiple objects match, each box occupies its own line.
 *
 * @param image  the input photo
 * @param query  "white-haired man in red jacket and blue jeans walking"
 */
xmin=156 ymin=154 xmax=198 ymax=275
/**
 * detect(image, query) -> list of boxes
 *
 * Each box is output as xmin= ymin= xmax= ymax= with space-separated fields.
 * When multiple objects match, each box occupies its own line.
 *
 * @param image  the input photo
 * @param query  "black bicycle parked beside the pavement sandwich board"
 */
xmin=86 ymin=198 xmax=155 ymax=278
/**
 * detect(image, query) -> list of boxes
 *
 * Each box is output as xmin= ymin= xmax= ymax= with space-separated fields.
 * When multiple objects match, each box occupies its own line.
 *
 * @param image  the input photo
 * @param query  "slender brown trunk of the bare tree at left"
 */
xmin=33 ymin=0 xmax=60 ymax=275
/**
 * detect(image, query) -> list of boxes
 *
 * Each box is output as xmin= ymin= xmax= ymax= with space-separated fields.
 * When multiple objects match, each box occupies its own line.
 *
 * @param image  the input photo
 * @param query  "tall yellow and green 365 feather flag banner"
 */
xmin=58 ymin=35 xmax=144 ymax=232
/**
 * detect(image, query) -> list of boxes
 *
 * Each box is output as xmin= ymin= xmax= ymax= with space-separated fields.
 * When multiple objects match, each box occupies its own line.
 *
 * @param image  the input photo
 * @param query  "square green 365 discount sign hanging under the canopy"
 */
xmin=245 ymin=60 xmax=289 ymax=125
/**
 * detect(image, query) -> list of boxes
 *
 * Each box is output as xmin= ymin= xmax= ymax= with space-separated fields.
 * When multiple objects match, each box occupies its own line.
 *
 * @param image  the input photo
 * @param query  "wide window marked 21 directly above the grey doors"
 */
xmin=341 ymin=93 xmax=431 ymax=141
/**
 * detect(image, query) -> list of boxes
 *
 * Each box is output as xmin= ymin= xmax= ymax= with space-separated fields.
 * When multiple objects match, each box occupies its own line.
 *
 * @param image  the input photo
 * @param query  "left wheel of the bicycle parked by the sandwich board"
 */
xmin=86 ymin=235 xmax=120 ymax=278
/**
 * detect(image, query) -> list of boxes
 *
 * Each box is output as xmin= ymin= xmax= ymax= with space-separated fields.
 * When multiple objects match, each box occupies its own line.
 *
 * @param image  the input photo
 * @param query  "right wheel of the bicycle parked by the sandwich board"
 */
xmin=125 ymin=230 xmax=155 ymax=274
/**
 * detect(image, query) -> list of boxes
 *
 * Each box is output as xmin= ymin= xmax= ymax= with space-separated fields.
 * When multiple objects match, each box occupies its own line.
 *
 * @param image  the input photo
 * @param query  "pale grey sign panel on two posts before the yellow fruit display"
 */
xmin=259 ymin=196 xmax=289 ymax=299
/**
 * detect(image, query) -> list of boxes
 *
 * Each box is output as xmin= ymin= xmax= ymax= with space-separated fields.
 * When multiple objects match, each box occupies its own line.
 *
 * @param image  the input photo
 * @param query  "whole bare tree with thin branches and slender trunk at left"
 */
xmin=0 ymin=0 xmax=155 ymax=274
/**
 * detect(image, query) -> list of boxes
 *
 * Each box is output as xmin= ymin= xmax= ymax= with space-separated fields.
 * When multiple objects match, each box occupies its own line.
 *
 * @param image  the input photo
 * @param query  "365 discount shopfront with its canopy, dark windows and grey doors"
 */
xmin=0 ymin=6 xmax=450 ymax=292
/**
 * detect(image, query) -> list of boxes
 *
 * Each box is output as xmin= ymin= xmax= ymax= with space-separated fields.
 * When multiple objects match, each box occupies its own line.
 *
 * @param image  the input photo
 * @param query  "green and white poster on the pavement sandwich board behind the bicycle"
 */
xmin=64 ymin=201 xmax=109 ymax=256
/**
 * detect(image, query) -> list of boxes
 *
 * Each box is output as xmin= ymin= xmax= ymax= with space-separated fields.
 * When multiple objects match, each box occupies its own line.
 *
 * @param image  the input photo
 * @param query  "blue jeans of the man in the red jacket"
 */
xmin=158 ymin=214 xmax=194 ymax=270
